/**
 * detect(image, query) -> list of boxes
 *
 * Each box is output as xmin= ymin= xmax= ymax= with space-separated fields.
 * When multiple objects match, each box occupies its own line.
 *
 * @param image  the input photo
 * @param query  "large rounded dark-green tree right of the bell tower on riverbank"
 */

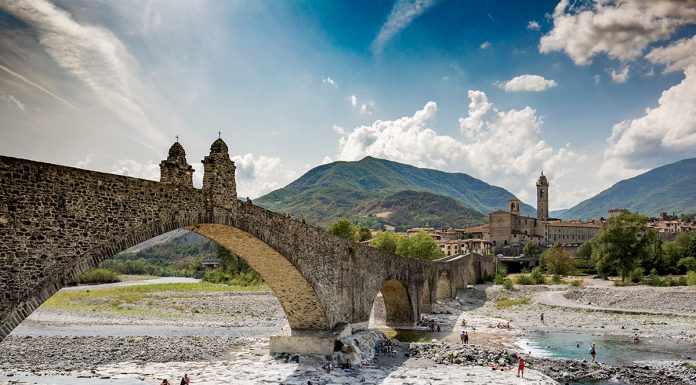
xmin=592 ymin=213 xmax=656 ymax=281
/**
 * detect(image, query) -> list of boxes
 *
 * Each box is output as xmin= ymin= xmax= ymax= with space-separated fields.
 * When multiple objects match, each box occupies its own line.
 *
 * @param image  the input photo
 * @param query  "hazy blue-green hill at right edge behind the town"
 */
xmin=560 ymin=158 xmax=696 ymax=219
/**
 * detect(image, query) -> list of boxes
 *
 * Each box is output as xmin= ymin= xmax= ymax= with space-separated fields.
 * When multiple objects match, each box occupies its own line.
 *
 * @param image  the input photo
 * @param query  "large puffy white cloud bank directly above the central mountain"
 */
xmin=337 ymin=90 xmax=581 ymax=205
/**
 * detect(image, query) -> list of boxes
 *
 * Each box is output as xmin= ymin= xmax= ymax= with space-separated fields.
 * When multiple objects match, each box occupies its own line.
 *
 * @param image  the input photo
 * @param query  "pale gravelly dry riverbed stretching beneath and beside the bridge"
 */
xmin=0 ymin=278 xmax=696 ymax=385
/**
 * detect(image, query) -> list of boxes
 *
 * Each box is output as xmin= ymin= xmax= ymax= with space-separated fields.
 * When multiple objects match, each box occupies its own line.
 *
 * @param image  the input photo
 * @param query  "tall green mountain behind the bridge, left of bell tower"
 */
xmin=254 ymin=157 xmax=535 ymax=227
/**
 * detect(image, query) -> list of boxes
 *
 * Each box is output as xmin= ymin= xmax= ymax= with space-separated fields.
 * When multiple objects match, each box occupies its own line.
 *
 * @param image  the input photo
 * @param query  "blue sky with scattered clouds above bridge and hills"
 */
xmin=0 ymin=0 xmax=696 ymax=210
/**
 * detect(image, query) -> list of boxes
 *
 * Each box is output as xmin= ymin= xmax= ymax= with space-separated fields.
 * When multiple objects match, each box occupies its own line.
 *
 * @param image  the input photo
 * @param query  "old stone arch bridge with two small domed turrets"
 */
xmin=0 ymin=139 xmax=494 ymax=348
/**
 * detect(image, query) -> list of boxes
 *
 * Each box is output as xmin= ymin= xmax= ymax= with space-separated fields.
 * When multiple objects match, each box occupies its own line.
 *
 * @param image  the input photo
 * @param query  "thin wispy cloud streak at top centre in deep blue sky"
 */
xmin=372 ymin=0 xmax=436 ymax=56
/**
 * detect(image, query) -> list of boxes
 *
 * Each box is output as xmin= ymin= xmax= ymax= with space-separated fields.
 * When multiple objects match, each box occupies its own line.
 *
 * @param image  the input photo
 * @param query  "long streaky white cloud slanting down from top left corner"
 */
xmin=0 ymin=0 xmax=167 ymax=148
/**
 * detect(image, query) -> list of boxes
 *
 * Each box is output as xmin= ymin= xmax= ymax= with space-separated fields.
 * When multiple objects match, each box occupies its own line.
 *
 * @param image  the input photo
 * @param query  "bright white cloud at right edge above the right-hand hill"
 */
xmin=601 ymin=66 xmax=696 ymax=178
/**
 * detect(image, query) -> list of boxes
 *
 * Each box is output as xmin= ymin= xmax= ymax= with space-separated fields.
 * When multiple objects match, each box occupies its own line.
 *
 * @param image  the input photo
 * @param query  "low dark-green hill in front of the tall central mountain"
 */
xmin=360 ymin=190 xmax=486 ymax=231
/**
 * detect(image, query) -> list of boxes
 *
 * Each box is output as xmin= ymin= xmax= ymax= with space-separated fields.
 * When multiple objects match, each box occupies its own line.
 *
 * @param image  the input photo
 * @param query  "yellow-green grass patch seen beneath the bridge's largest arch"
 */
xmin=41 ymin=282 xmax=269 ymax=318
